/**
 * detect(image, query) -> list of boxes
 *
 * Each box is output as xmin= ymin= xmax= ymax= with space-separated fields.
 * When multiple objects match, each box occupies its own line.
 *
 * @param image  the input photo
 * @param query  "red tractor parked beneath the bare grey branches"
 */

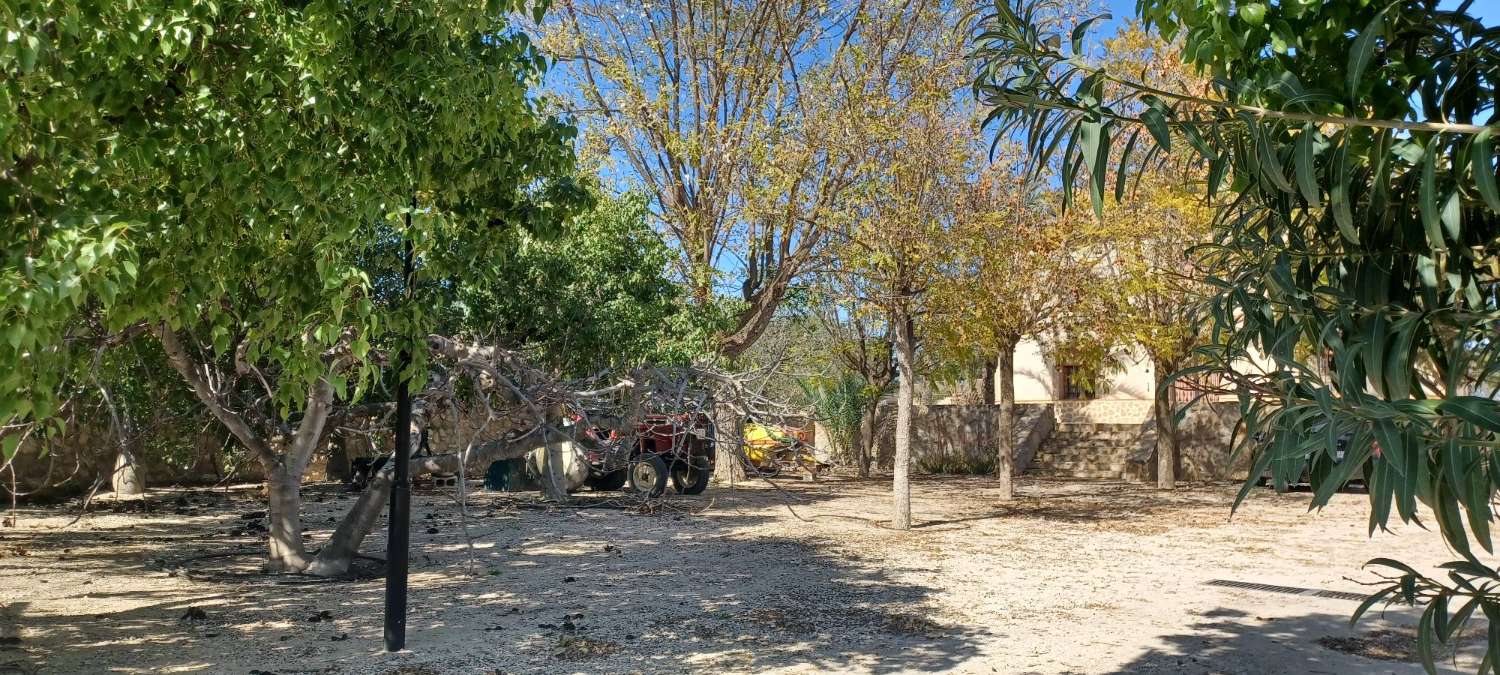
xmin=584 ymin=414 xmax=714 ymax=497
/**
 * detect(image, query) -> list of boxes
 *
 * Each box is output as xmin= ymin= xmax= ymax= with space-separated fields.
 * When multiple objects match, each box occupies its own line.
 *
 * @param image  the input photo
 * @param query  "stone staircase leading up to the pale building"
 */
xmin=1026 ymin=425 xmax=1142 ymax=480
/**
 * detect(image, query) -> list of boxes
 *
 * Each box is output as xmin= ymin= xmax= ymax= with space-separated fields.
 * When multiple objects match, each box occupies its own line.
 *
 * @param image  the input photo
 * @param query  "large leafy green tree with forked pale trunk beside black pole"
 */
xmin=0 ymin=0 xmax=584 ymax=573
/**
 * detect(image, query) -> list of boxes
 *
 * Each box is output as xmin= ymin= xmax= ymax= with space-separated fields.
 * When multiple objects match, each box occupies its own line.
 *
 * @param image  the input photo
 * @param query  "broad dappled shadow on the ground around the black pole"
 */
xmin=0 ymin=489 xmax=987 ymax=674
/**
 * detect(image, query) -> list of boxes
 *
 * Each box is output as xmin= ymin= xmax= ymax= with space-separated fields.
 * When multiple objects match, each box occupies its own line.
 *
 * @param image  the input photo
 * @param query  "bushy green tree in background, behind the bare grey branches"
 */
xmin=440 ymin=194 xmax=717 ymax=377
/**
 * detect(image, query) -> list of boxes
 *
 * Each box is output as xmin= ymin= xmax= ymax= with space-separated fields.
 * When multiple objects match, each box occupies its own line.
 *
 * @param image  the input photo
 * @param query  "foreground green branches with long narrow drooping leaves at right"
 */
xmin=977 ymin=0 xmax=1500 ymax=671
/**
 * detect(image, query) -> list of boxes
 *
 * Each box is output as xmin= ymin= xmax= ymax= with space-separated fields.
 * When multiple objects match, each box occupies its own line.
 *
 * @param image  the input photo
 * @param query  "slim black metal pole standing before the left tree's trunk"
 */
xmin=386 ymin=210 xmax=416 ymax=651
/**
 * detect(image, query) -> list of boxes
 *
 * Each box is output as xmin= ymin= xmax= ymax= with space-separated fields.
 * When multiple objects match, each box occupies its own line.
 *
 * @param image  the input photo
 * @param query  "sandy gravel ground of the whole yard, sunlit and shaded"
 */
xmin=0 ymin=477 xmax=1475 ymax=674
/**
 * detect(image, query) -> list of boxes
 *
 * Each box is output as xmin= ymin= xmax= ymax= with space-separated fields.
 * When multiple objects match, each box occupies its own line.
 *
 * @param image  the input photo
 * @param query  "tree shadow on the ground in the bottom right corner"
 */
xmin=1116 ymin=608 xmax=1484 ymax=675
